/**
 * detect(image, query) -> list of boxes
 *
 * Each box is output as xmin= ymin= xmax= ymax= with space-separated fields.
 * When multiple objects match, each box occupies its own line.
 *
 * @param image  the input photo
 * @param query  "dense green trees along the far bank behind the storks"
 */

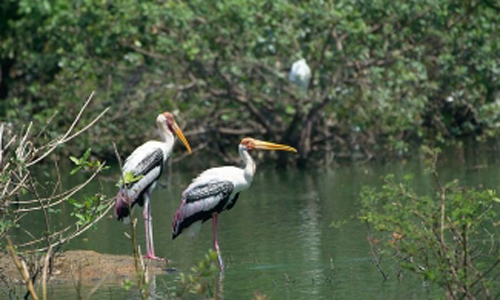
xmin=0 ymin=0 xmax=500 ymax=164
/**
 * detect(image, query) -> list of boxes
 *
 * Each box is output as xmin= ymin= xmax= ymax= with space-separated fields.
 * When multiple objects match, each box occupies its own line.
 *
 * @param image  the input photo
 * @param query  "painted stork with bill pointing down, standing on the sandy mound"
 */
xmin=115 ymin=112 xmax=191 ymax=260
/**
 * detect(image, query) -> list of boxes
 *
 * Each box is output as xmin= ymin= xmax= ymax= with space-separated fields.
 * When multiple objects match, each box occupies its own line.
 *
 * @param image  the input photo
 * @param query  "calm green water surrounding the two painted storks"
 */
xmin=12 ymin=145 xmax=500 ymax=299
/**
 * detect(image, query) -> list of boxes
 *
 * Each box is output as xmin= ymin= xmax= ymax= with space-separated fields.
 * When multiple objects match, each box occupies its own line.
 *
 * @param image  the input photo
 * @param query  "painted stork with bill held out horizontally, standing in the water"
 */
xmin=172 ymin=138 xmax=297 ymax=271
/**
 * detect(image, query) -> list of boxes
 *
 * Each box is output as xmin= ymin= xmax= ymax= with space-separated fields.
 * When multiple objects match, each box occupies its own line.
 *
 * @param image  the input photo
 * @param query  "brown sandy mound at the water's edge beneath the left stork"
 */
xmin=0 ymin=250 xmax=168 ymax=284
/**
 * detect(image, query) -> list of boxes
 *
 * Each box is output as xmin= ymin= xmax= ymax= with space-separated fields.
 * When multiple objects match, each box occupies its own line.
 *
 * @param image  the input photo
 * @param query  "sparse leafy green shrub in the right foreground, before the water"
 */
xmin=359 ymin=149 xmax=500 ymax=299
